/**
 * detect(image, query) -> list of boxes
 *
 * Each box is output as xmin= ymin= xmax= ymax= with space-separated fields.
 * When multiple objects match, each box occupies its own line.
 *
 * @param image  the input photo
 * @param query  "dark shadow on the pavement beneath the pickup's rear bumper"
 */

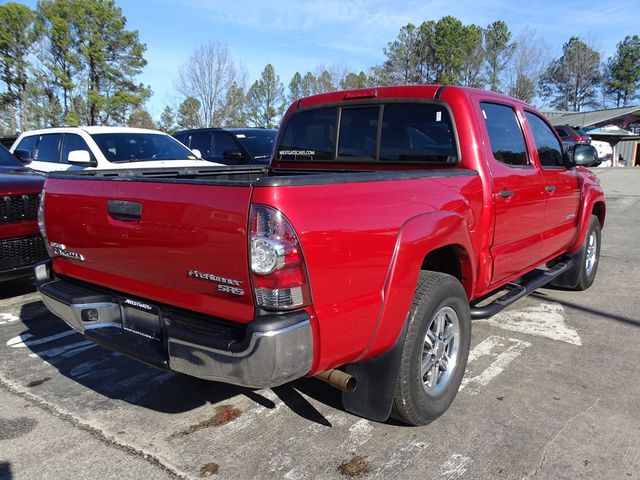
xmin=13 ymin=301 xmax=342 ymax=426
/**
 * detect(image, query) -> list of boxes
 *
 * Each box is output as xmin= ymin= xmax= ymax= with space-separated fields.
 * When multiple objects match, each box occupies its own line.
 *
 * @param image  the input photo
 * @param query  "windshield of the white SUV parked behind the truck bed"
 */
xmin=91 ymin=133 xmax=196 ymax=163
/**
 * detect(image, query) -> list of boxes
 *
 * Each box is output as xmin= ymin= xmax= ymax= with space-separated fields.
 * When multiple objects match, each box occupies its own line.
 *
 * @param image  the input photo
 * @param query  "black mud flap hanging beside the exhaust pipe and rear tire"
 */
xmin=342 ymin=322 xmax=407 ymax=422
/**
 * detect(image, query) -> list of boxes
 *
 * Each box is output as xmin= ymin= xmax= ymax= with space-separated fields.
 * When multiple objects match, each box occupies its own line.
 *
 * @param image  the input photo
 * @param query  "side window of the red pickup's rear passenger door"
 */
xmin=480 ymin=102 xmax=529 ymax=167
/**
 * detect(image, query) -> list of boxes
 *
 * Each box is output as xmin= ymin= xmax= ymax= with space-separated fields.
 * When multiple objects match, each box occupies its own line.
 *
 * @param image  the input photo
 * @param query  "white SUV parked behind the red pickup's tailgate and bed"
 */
xmin=11 ymin=127 xmax=220 ymax=172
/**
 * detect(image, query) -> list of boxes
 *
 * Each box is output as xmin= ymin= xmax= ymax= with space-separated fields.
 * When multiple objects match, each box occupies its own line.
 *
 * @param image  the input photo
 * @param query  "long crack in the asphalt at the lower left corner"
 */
xmin=0 ymin=376 xmax=185 ymax=480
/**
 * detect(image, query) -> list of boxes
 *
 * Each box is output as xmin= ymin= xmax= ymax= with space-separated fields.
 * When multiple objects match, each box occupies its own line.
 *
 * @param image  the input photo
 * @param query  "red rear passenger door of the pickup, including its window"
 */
xmin=477 ymin=99 xmax=544 ymax=284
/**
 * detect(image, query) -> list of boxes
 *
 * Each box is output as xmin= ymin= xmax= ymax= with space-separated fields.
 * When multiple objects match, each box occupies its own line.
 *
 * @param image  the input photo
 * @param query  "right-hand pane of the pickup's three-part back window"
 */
xmin=380 ymin=103 xmax=457 ymax=163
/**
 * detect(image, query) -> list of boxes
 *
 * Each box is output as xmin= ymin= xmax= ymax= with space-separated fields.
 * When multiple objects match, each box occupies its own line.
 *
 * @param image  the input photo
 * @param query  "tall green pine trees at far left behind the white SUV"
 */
xmin=0 ymin=0 xmax=151 ymax=133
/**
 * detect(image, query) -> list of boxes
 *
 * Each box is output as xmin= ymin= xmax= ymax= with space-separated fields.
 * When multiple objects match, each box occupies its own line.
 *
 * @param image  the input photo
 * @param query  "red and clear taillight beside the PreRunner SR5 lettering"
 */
xmin=249 ymin=205 xmax=311 ymax=310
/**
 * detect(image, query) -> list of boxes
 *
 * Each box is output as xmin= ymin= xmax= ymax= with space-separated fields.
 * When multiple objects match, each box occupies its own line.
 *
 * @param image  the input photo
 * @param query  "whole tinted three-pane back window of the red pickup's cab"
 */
xmin=276 ymin=103 xmax=458 ymax=164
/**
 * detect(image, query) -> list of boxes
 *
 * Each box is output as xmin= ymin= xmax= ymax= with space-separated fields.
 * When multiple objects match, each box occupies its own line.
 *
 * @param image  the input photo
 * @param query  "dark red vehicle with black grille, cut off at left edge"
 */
xmin=0 ymin=146 xmax=47 ymax=281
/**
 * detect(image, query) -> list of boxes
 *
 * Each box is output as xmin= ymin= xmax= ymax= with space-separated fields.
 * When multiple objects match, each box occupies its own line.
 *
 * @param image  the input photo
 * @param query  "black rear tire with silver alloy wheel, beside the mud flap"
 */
xmin=391 ymin=272 xmax=471 ymax=425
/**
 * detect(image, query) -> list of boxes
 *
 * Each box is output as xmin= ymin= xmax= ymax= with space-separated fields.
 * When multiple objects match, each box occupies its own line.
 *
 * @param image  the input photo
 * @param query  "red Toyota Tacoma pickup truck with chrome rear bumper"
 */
xmin=35 ymin=86 xmax=605 ymax=424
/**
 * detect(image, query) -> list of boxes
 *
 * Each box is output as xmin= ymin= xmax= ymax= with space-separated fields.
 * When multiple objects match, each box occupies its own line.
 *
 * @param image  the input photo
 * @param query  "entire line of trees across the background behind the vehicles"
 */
xmin=0 ymin=0 xmax=640 ymax=133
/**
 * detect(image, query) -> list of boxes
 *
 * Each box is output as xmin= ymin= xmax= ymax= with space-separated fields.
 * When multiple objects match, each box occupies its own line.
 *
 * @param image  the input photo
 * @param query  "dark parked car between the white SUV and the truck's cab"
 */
xmin=173 ymin=128 xmax=277 ymax=165
